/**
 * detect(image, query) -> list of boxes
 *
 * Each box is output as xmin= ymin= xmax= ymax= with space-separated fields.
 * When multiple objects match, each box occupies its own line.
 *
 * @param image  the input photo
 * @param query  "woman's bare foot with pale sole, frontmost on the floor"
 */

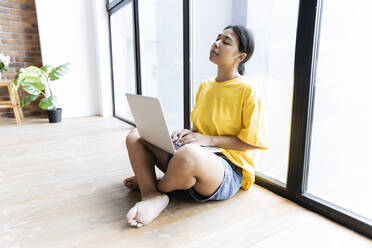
xmin=127 ymin=192 xmax=169 ymax=227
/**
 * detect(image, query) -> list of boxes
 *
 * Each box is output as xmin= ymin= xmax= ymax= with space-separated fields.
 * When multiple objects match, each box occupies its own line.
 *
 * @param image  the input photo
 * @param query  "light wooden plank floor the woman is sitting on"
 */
xmin=0 ymin=117 xmax=372 ymax=248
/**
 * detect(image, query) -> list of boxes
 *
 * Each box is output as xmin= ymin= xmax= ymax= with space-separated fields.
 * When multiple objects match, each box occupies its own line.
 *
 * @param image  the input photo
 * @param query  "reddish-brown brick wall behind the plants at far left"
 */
xmin=0 ymin=0 xmax=45 ymax=118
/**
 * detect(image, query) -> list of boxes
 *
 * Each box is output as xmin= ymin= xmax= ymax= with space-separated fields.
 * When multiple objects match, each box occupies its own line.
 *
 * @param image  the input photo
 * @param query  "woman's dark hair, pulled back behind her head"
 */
xmin=224 ymin=25 xmax=254 ymax=75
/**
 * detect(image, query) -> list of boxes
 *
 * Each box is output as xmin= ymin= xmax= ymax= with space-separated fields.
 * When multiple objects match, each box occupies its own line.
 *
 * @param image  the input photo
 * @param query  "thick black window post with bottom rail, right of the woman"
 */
xmin=256 ymin=0 xmax=372 ymax=238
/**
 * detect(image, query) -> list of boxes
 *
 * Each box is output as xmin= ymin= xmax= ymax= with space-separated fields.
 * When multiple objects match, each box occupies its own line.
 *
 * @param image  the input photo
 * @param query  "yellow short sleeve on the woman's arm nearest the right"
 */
xmin=237 ymin=86 xmax=269 ymax=150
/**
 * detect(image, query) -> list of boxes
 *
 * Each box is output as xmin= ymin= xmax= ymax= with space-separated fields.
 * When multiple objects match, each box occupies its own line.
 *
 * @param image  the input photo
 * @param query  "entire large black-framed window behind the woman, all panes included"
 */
xmin=107 ymin=0 xmax=372 ymax=237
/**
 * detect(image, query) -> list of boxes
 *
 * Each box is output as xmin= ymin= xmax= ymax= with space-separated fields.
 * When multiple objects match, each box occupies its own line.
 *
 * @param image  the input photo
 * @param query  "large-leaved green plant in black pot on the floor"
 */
xmin=14 ymin=63 xmax=69 ymax=123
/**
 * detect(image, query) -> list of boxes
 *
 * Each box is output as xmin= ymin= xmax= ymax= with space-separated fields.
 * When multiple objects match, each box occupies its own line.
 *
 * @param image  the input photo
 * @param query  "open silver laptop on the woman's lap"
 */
xmin=126 ymin=93 xmax=221 ymax=154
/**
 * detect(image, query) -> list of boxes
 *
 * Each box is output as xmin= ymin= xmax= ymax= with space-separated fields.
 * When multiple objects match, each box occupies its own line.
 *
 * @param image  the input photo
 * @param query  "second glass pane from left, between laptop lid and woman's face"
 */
xmin=138 ymin=0 xmax=183 ymax=132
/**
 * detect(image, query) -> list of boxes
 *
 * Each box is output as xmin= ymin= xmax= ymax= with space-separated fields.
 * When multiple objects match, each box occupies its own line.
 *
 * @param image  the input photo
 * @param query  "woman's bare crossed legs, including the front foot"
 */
xmin=126 ymin=129 xmax=224 ymax=227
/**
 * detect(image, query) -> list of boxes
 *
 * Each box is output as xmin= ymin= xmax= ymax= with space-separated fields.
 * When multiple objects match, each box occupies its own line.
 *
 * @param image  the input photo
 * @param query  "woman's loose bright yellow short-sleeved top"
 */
xmin=191 ymin=76 xmax=269 ymax=190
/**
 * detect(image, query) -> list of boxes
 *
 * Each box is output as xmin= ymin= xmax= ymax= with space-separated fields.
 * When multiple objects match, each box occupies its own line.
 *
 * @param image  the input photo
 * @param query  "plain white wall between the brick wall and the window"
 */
xmin=35 ymin=0 xmax=112 ymax=117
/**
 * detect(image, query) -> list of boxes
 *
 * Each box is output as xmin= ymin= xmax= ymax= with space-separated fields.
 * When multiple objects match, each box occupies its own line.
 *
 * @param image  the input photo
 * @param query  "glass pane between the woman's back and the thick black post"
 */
xmin=246 ymin=0 xmax=299 ymax=183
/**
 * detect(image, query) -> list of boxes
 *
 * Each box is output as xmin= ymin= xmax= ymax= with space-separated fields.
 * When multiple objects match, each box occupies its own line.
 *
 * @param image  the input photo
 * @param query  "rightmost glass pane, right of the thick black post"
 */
xmin=307 ymin=0 xmax=372 ymax=219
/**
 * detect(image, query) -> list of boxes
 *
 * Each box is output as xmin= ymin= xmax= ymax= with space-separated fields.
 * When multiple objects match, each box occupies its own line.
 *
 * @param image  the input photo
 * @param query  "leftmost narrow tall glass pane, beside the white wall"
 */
xmin=111 ymin=2 xmax=136 ymax=120
